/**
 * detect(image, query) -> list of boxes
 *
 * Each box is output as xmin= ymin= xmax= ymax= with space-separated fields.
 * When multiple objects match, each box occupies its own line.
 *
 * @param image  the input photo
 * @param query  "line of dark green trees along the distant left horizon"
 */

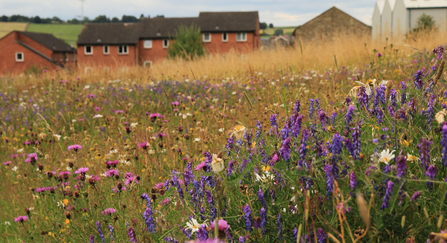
xmin=0 ymin=14 xmax=164 ymax=24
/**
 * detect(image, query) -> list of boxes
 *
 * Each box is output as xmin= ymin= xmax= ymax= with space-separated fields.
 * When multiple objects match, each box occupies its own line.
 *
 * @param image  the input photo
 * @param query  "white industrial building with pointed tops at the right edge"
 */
xmin=372 ymin=0 xmax=447 ymax=38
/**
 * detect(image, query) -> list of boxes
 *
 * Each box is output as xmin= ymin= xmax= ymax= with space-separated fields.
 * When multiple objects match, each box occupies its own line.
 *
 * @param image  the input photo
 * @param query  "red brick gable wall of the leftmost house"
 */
xmin=0 ymin=32 xmax=56 ymax=74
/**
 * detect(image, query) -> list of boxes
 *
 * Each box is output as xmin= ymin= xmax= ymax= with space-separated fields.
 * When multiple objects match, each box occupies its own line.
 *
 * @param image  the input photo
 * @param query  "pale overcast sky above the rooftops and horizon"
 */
xmin=0 ymin=0 xmax=376 ymax=26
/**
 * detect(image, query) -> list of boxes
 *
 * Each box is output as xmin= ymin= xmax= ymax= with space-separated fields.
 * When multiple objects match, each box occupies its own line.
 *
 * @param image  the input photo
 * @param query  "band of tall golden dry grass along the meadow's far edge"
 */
xmin=1 ymin=32 xmax=447 ymax=85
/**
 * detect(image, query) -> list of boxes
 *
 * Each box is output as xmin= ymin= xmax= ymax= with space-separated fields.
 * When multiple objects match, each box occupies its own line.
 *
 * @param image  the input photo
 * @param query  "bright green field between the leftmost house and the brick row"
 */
xmin=28 ymin=24 xmax=83 ymax=44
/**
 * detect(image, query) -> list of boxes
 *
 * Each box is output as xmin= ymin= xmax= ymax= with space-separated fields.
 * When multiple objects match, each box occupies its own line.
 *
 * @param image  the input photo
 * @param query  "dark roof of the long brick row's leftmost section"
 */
xmin=77 ymin=23 xmax=139 ymax=45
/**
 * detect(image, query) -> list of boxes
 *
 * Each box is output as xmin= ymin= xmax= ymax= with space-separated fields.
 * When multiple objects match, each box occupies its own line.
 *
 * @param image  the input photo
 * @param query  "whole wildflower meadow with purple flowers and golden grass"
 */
xmin=0 ymin=33 xmax=447 ymax=243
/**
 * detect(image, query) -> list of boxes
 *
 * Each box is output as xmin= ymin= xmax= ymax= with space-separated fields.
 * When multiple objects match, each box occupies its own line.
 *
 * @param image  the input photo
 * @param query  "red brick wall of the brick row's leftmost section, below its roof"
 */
xmin=77 ymin=45 xmax=138 ymax=68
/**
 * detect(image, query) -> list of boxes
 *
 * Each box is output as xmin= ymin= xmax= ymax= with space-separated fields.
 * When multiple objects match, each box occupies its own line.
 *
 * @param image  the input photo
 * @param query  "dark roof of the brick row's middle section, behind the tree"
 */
xmin=138 ymin=18 xmax=198 ymax=39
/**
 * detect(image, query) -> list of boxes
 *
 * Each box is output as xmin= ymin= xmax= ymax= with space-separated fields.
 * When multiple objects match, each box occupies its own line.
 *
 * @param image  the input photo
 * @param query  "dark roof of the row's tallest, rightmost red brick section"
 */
xmin=199 ymin=11 xmax=259 ymax=32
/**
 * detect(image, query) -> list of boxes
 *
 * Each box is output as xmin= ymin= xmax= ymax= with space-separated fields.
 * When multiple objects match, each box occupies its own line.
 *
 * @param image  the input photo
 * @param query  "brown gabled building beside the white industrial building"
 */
xmin=293 ymin=7 xmax=371 ymax=42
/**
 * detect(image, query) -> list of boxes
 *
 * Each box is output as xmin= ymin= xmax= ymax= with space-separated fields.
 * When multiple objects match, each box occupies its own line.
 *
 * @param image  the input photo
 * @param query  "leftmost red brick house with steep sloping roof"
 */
xmin=0 ymin=31 xmax=76 ymax=74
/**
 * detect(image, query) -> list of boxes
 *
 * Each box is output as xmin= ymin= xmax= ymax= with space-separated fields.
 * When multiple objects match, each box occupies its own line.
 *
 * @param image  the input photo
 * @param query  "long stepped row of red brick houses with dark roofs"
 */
xmin=77 ymin=12 xmax=260 ymax=71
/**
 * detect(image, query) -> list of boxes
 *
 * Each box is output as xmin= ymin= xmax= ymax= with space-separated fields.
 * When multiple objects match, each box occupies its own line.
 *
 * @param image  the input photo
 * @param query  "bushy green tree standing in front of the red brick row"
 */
xmin=168 ymin=25 xmax=205 ymax=60
